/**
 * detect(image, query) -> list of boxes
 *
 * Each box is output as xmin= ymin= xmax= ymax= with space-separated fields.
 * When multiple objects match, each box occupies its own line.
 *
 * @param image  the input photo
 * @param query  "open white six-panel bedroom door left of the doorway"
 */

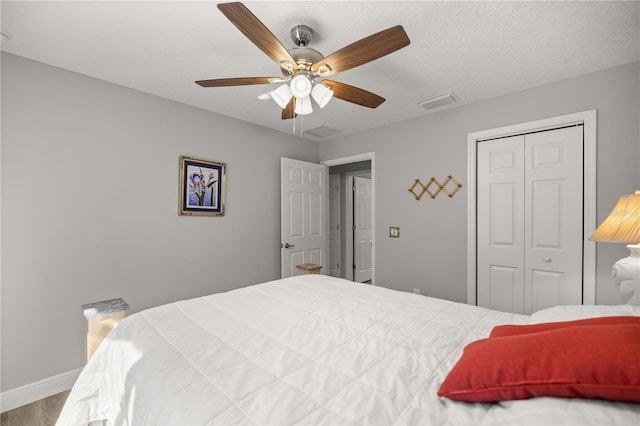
xmin=280 ymin=158 xmax=326 ymax=278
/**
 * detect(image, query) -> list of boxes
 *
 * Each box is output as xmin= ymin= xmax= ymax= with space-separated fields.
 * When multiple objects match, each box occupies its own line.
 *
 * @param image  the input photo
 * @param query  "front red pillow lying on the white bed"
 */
xmin=438 ymin=324 xmax=640 ymax=402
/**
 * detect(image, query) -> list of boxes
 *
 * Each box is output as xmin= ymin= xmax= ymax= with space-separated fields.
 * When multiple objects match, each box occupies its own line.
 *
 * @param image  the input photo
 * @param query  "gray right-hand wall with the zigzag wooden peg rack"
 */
xmin=320 ymin=62 xmax=640 ymax=304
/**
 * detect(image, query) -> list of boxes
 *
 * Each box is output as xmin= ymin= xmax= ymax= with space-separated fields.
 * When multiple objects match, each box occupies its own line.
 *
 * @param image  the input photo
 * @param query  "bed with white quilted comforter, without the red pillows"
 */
xmin=58 ymin=275 xmax=640 ymax=425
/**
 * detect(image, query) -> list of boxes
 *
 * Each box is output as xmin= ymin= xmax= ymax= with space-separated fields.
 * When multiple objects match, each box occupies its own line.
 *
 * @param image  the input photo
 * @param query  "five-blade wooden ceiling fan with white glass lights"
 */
xmin=196 ymin=2 xmax=410 ymax=120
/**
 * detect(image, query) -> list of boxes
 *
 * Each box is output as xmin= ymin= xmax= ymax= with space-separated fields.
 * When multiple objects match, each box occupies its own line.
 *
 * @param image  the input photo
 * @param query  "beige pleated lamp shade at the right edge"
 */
xmin=590 ymin=190 xmax=640 ymax=244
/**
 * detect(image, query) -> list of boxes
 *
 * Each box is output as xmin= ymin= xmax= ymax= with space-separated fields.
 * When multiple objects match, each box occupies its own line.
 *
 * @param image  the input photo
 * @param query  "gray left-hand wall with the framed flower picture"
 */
xmin=1 ymin=53 xmax=318 ymax=391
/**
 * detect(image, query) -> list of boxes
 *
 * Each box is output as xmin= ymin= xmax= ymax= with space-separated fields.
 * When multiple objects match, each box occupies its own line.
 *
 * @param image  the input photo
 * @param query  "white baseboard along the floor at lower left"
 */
xmin=0 ymin=368 xmax=82 ymax=413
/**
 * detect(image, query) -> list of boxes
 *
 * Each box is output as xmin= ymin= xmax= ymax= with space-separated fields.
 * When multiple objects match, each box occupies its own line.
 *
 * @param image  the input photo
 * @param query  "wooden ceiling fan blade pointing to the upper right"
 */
xmin=311 ymin=25 xmax=411 ymax=77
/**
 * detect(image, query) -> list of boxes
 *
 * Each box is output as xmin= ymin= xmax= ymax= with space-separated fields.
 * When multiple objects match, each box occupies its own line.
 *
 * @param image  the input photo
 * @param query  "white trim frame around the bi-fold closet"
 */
xmin=467 ymin=109 xmax=597 ymax=305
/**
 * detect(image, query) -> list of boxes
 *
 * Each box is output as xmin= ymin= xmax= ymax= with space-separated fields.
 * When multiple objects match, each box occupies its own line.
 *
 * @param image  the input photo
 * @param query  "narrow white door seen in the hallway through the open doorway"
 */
xmin=353 ymin=176 xmax=373 ymax=283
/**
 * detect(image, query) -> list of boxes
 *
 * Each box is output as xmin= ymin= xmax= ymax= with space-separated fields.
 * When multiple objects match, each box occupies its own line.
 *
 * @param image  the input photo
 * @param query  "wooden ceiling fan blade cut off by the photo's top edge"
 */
xmin=218 ymin=2 xmax=297 ymax=71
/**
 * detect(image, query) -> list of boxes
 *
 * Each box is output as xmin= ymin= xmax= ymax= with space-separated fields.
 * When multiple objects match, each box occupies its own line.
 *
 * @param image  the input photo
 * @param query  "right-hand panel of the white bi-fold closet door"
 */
xmin=524 ymin=126 xmax=583 ymax=314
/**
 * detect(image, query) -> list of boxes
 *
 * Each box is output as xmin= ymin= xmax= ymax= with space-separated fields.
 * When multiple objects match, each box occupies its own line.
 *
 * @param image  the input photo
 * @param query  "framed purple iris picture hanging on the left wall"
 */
xmin=180 ymin=157 xmax=227 ymax=216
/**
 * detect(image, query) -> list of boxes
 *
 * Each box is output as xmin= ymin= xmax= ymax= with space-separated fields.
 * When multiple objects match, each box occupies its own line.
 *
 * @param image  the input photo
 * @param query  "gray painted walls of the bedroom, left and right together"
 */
xmin=1 ymin=53 xmax=640 ymax=391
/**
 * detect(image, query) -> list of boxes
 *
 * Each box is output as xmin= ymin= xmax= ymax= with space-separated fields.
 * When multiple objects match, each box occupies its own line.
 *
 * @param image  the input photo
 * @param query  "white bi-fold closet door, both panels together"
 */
xmin=477 ymin=125 xmax=584 ymax=314
